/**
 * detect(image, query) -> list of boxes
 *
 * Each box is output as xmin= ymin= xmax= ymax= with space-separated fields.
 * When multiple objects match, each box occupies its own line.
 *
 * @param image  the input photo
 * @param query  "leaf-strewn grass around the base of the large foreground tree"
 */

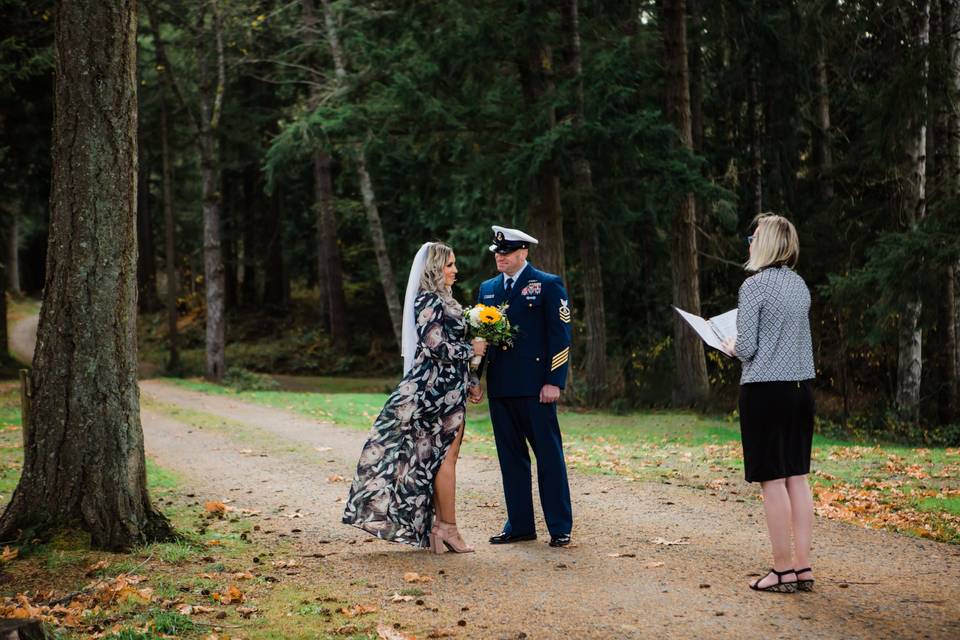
xmin=0 ymin=382 xmax=390 ymax=640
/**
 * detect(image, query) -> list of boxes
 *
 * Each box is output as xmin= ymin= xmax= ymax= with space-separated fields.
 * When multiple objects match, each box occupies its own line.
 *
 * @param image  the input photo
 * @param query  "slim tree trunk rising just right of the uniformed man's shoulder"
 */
xmin=562 ymin=0 xmax=607 ymax=406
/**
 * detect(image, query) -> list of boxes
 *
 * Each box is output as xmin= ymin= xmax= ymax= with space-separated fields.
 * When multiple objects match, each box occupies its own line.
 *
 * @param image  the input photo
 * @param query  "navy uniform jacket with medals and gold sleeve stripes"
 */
xmin=477 ymin=264 xmax=571 ymax=398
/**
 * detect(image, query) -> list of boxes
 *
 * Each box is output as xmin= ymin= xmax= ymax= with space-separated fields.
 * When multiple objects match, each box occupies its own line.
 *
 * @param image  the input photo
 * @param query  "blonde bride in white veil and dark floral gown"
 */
xmin=343 ymin=242 xmax=486 ymax=553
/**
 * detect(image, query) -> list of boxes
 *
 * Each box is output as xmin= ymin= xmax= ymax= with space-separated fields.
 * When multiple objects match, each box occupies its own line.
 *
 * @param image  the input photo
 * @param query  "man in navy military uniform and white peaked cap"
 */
xmin=475 ymin=226 xmax=573 ymax=547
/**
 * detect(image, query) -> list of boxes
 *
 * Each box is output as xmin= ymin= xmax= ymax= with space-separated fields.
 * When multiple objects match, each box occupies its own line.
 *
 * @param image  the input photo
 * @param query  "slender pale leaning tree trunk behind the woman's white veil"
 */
xmin=321 ymin=0 xmax=403 ymax=347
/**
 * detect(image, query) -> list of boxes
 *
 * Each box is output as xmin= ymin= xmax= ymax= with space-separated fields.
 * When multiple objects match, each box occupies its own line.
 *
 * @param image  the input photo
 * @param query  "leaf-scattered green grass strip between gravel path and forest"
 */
xmin=167 ymin=377 xmax=960 ymax=544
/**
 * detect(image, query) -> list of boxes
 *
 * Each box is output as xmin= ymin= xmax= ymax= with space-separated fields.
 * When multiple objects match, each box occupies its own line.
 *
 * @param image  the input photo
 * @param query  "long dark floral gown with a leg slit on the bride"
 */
xmin=343 ymin=292 xmax=473 ymax=547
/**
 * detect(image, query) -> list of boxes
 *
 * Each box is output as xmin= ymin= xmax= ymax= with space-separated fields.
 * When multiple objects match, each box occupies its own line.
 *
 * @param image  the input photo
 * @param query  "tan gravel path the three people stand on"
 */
xmin=141 ymin=381 xmax=960 ymax=639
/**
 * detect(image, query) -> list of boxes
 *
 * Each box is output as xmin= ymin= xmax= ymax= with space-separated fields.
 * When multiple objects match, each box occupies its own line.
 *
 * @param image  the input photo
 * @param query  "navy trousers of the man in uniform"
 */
xmin=490 ymin=397 xmax=573 ymax=536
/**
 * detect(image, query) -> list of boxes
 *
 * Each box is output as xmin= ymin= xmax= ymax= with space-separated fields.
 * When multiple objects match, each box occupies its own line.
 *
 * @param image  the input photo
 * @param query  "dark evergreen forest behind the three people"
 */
xmin=0 ymin=0 xmax=960 ymax=445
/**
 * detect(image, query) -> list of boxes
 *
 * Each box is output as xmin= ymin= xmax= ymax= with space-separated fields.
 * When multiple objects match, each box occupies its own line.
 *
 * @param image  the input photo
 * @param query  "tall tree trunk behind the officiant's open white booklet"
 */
xmin=663 ymin=0 xmax=710 ymax=406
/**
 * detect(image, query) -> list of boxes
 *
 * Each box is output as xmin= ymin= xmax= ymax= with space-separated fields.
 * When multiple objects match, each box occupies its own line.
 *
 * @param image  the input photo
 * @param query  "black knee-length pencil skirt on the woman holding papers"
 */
xmin=740 ymin=380 xmax=814 ymax=482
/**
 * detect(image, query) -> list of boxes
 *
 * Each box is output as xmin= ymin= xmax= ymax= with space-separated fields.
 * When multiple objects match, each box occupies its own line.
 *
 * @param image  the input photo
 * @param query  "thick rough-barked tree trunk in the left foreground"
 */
xmin=0 ymin=0 xmax=171 ymax=549
